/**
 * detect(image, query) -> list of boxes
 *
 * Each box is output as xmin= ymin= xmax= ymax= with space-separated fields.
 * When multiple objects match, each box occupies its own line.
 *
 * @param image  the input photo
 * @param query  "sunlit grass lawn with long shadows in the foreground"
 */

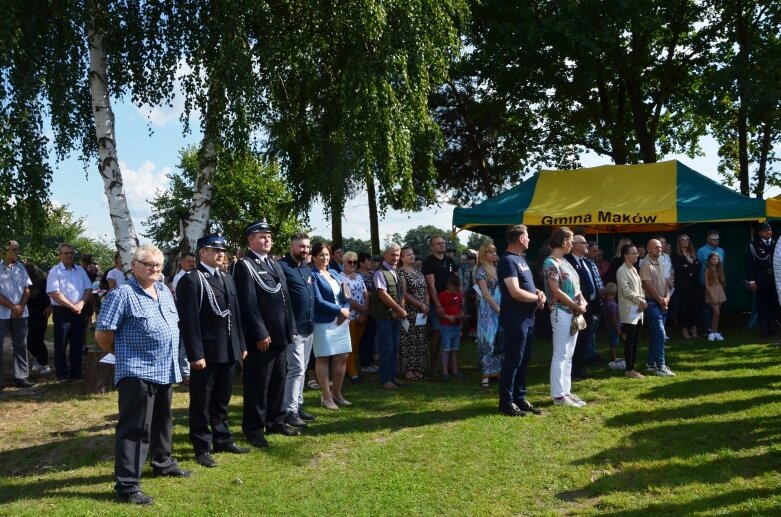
xmin=0 ymin=320 xmax=781 ymax=516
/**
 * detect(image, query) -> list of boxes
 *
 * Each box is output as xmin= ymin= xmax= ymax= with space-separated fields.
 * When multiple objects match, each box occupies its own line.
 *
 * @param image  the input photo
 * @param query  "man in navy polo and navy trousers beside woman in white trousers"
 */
xmin=497 ymin=224 xmax=545 ymax=416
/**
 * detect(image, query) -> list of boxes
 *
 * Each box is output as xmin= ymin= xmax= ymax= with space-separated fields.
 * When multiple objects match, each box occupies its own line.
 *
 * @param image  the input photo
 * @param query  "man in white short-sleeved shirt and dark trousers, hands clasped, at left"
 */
xmin=46 ymin=243 xmax=92 ymax=382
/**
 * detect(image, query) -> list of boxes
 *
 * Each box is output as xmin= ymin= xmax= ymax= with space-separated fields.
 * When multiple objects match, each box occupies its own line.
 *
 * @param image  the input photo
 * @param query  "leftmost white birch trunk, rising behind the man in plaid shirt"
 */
xmin=88 ymin=29 xmax=138 ymax=271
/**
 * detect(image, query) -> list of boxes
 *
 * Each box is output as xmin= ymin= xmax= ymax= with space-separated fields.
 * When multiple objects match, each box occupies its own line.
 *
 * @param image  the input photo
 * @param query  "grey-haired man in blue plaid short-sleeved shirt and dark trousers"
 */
xmin=95 ymin=245 xmax=192 ymax=505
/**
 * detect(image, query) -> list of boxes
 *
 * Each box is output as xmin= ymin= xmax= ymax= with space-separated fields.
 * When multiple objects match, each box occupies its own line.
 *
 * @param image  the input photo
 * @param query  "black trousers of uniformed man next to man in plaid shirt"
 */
xmin=189 ymin=362 xmax=238 ymax=455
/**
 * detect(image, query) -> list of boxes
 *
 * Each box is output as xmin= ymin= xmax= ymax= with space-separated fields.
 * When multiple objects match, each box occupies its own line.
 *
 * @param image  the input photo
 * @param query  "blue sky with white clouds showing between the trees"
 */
xmin=52 ymin=95 xmax=778 ymax=249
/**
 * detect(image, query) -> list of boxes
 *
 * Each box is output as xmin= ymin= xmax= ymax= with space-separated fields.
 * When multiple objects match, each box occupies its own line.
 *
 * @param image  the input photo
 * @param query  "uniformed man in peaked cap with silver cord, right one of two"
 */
xmin=233 ymin=220 xmax=301 ymax=447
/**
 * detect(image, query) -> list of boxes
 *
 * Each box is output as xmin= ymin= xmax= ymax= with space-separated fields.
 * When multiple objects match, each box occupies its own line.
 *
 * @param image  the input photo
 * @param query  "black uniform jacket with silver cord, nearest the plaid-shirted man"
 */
xmin=176 ymin=264 xmax=246 ymax=365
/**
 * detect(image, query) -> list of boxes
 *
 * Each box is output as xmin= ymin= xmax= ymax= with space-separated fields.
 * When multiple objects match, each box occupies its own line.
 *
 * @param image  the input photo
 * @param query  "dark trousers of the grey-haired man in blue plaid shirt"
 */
xmin=114 ymin=377 xmax=179 ymax=494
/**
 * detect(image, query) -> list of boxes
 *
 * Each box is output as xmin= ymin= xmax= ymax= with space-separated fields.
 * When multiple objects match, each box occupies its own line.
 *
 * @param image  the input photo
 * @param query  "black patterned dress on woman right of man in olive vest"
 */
xmin=397 ymin=268 xmax=429 ymax=372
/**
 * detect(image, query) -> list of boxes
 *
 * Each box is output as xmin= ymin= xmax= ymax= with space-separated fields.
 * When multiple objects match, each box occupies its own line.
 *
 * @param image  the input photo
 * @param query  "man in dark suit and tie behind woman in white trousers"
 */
xmin=564 ymin=235 xmax=604 ymax=379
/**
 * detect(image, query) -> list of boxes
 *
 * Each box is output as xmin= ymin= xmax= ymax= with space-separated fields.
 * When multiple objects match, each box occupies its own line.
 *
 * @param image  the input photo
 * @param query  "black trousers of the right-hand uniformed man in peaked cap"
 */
xmin=241 ymin=343 xmax=287 ymax=441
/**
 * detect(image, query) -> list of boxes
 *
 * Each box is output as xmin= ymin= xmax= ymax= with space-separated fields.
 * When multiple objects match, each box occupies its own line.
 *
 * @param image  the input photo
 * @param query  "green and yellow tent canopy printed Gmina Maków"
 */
xmin=453 ymin=160 xmax=765 ymax=233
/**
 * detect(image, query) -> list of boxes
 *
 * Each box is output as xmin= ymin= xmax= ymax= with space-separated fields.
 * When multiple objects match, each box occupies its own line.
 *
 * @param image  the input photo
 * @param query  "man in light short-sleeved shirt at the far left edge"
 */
xmin=0 ymin=241 xmax=32 ymax=388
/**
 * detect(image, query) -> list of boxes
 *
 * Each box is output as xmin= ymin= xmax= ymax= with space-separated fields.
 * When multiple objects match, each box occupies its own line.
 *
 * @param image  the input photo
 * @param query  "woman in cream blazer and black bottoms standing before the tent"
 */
xmin=616 ymin=244 xmax=648 ymax=379
